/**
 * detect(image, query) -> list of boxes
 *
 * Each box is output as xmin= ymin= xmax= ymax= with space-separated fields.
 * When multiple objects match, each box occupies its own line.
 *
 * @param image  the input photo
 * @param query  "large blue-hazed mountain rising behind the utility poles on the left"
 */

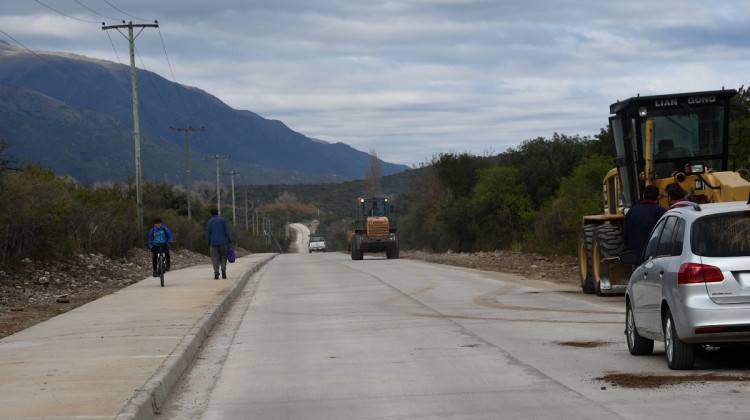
xmin=0 ymin=42 xmax=409 ymax=184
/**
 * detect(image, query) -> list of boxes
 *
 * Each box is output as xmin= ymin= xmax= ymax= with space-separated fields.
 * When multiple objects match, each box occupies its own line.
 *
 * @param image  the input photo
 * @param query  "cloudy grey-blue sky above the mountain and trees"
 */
xmin=0 ymin=0 xmax=750 ymax=166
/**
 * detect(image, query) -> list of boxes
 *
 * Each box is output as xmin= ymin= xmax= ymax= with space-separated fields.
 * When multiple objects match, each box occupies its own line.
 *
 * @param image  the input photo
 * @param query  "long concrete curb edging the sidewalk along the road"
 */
xmin=115 ymin=254 xmax=278 ymax=420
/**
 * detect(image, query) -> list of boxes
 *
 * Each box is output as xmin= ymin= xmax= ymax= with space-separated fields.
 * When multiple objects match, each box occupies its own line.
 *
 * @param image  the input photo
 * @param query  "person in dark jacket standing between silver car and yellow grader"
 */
xmin=622 ymin=185 xmax=667 ymax=255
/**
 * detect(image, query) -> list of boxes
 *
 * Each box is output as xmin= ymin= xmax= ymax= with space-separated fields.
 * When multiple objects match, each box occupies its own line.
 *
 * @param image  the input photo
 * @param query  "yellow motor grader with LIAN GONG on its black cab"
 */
xmin=578 ymin=89 xmax=750 ymax=295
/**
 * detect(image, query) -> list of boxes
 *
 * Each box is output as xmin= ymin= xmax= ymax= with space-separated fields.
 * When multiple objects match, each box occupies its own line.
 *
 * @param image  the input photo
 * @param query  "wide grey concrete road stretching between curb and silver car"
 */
xmin=160 ymin=253 xmax=750 ymax=420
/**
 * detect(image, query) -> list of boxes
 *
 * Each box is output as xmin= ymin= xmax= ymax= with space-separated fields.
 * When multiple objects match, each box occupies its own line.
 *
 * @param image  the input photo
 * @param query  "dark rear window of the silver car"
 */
xmin=690 ymin=213 xmax=750 ymax=257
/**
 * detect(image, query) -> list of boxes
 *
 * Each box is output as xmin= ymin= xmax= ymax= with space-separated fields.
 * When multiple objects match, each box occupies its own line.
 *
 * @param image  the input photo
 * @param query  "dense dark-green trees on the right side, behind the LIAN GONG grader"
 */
xmin=398 ymin=86 xmax=750 ymax=255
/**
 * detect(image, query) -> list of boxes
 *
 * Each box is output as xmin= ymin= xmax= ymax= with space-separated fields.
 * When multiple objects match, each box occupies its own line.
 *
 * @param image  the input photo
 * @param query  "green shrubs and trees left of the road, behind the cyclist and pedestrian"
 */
xmin=0 ymin=140 xmax=289 ymax=269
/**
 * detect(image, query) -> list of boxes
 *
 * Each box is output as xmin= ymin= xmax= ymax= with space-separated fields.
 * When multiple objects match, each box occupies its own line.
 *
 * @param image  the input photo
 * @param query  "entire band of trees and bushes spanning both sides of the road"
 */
xmin=0 ymin=87 xmax=750 ymax=268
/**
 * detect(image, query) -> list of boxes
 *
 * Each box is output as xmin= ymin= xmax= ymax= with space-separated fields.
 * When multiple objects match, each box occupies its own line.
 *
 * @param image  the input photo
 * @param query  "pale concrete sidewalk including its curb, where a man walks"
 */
xmin=0 ymin=254 xmax=276 ymax=419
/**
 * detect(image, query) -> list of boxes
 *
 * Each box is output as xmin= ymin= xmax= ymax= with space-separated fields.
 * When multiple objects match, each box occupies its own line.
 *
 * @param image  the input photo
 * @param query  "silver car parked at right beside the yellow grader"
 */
xmin=620 ymin=202 xmax=750 ymax=369
